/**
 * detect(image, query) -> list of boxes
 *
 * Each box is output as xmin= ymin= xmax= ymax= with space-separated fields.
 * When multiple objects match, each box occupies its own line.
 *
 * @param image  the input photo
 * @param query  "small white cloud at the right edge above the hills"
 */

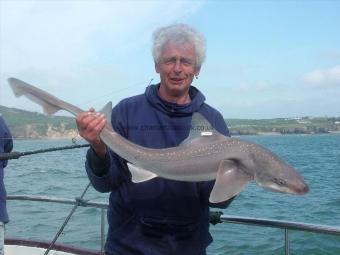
xmin=302 ymin=65 xmax=340 ymax=87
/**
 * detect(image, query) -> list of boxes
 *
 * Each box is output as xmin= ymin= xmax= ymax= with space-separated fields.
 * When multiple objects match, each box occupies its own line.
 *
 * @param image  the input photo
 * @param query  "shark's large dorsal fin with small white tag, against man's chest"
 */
xmin=181 ymin=112 xmax=221 ymax=144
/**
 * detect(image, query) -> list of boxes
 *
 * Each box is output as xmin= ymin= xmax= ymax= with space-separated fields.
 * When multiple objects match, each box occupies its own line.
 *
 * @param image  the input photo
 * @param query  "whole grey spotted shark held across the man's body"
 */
xmin=8 ymin=78 xmax=309 ymax=203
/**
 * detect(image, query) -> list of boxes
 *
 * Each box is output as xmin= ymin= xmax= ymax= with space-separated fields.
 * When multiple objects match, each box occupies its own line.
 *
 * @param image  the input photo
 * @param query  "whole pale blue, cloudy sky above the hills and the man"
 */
xmin=0 ymin=0 xmax=340 ymax=119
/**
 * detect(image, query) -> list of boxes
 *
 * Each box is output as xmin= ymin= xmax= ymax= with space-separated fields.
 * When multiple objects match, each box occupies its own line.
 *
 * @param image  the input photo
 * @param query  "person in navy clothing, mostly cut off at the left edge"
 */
xmin=0 ymin=116 xmax=13 ymax=255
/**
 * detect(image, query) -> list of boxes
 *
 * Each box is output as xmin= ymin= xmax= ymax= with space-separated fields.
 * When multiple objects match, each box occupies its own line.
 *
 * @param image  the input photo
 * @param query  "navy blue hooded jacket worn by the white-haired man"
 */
xmin=86 ymin=85 xmax=231 ymax=255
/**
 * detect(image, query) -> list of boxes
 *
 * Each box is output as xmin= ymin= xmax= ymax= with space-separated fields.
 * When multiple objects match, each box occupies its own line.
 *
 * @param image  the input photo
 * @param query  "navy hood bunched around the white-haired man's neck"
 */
xmin=145 ymin=84 xmax=205 ymax=116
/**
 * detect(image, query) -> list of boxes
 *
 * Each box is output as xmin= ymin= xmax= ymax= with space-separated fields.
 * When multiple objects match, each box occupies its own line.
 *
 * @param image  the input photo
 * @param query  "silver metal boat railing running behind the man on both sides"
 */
xmin=7 ymin=195 xmax=340 ymax=255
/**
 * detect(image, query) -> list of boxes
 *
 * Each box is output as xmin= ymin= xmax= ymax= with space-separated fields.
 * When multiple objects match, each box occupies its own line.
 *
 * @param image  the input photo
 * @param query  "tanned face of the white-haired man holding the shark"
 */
xmin=155 ymin=42 xmax=200 ymax=97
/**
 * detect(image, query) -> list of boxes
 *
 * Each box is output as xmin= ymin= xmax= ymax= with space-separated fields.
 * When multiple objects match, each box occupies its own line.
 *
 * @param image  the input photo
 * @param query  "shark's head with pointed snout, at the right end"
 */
xmin=248 ymin=145 xmax=309 ymax=195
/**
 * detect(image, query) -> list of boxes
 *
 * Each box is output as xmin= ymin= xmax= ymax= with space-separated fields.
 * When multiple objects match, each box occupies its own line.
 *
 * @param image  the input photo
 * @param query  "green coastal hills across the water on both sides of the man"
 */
xmin=0 ymin=106 xmax=340 ymax=138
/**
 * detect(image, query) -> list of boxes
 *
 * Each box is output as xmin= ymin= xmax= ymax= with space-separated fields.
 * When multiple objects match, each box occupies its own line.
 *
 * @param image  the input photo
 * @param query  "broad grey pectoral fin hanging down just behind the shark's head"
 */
xmin=209 ymin=160 xmax=253 ymax=203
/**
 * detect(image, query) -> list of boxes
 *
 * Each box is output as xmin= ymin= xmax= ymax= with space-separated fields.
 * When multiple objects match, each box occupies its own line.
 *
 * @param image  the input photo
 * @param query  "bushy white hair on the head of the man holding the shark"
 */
xmin=152 ymin=24 xmax=206 ymax=67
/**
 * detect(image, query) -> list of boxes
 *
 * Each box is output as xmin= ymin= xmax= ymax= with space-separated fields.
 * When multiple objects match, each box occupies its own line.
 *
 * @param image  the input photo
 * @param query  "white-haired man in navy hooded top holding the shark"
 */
xmin=76 ymin=25 xmax=231 ymax=255
